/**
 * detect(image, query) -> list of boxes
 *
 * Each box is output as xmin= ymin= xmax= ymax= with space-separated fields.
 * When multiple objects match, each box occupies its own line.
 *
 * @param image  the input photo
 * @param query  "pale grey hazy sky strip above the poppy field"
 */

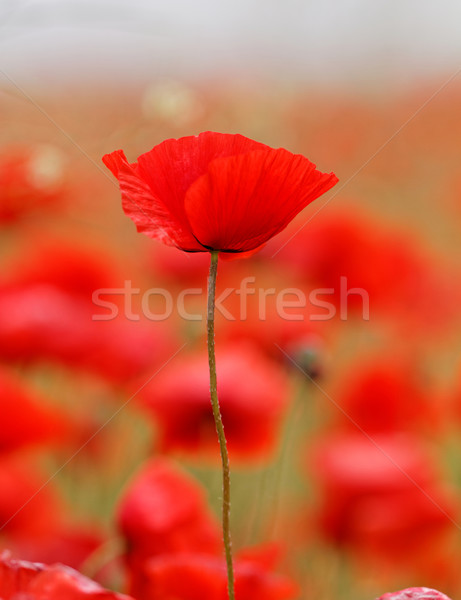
xmin=0 ymin=0 xmax=461 ymax=86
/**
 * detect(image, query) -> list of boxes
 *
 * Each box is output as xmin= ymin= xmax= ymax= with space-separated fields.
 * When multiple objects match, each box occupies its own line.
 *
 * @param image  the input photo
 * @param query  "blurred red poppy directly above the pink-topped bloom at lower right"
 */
xmin=334 ymin=356 xmax=434 ymax=434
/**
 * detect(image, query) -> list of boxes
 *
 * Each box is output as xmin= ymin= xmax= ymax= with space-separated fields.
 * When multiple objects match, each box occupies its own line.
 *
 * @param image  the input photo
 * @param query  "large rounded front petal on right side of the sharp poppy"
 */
xmin=185 ymin=147 xmax=338 ymax=252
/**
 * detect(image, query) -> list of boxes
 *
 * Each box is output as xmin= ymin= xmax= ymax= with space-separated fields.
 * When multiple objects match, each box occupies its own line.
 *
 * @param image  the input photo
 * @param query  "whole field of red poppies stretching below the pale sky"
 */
xmin=0 ymin=81 xmax=461 ymax=600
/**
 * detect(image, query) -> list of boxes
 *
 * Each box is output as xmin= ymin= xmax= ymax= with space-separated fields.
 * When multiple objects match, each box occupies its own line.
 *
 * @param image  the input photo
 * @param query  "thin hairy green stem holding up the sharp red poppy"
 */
xmin=207 ymin=250 xmax=235 ymax=600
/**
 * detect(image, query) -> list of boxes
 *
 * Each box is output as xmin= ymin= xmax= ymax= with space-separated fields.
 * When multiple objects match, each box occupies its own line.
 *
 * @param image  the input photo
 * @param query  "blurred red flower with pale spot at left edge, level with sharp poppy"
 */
xmin=0 ymin=146 xmax=64 ymax=223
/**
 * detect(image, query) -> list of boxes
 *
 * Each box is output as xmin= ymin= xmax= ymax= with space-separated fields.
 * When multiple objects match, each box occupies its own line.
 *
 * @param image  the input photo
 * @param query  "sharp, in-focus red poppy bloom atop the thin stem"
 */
xmin=103 ymin=131 xmax=338 ymax=253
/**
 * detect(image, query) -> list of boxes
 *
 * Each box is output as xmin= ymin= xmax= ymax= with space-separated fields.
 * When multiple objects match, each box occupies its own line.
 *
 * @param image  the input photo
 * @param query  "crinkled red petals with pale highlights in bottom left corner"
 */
xmin=0 ymin=553 xmax=132 ymax=600
